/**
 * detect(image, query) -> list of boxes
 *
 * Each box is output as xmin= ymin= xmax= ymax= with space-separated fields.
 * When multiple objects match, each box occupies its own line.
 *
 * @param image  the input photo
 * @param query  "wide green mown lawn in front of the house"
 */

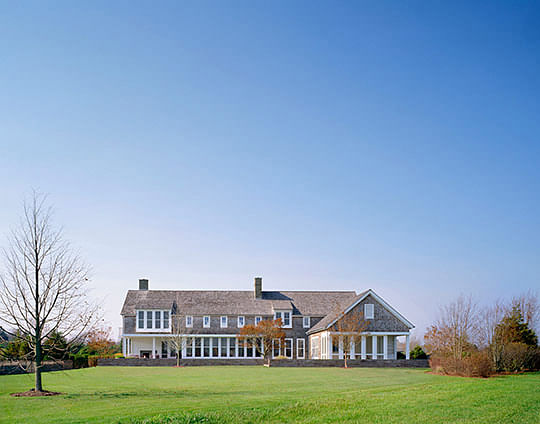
xmin=0 ymin=366 xmax=540 ymax=424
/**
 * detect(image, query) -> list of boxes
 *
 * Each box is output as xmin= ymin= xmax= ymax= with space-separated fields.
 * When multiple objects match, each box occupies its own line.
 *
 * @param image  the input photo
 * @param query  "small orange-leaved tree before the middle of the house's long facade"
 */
xmin=238 ymin=318 xmax=285 ymax=367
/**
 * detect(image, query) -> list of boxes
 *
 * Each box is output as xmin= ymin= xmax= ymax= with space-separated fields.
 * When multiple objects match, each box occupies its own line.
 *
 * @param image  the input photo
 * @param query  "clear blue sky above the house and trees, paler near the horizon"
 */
xmin=0 ymin=1 xmax=540 ymax=335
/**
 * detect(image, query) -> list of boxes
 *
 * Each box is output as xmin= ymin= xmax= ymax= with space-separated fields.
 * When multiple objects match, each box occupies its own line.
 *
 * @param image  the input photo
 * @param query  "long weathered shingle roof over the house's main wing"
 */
xmin=121 ymin=290 xmax=356 ymax=317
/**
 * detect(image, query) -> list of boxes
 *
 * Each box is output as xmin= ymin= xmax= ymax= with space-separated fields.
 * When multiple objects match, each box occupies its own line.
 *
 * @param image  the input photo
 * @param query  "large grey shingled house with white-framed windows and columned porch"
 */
xmin=121 ymin=277 xmax=414 ymax=359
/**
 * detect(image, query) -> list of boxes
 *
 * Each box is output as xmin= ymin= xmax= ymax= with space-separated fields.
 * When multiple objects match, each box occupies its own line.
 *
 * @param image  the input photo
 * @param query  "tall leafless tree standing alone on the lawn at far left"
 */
xmin=0 ymin=192 xmax=97 ymax=392
